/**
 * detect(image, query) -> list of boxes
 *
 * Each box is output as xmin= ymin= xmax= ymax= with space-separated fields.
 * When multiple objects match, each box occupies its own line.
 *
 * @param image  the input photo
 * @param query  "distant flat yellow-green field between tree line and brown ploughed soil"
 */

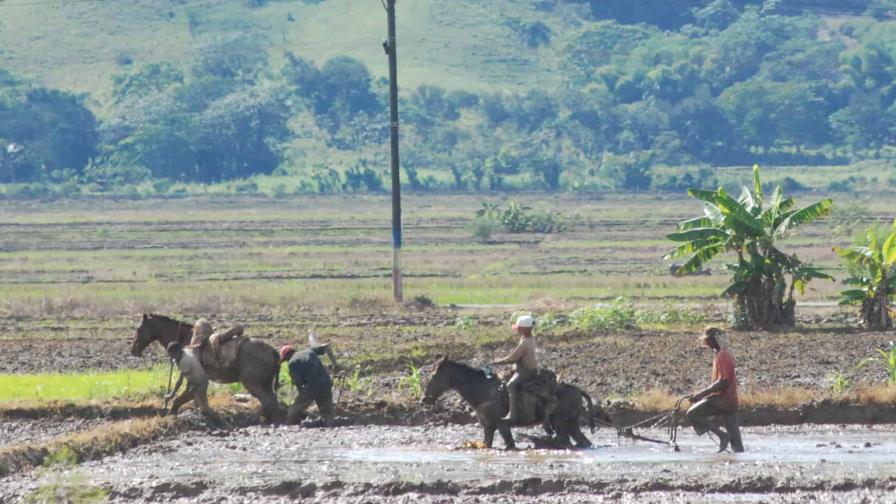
xmin=0 ymin=194 xmax=872 ymax=334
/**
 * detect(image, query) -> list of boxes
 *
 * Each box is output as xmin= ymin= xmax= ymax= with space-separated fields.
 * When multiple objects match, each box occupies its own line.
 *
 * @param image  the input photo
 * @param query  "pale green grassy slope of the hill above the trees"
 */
xmin=0 ymin=0 xmax=571 ymax=105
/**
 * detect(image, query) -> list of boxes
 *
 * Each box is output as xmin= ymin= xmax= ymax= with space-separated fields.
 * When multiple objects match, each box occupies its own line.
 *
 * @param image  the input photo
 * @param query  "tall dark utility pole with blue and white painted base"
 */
xmin=383 ymin=0 xmax=404 ymax=303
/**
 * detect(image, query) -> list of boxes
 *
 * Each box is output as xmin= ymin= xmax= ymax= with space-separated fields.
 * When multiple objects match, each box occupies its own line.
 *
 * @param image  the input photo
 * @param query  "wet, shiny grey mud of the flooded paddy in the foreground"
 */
xmin=0 ymin=425 xmax=896 ymax=502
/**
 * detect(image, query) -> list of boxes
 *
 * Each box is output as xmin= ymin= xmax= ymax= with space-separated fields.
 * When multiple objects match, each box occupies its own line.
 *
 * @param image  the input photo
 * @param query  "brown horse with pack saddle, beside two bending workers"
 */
xmin=131 ymin=314 xmax=280 ymax=423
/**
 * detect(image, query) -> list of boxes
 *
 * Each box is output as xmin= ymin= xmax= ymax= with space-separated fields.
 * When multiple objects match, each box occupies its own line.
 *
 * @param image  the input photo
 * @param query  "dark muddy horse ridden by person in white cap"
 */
xmin=421 ymin=357 xmax=595 ymax=448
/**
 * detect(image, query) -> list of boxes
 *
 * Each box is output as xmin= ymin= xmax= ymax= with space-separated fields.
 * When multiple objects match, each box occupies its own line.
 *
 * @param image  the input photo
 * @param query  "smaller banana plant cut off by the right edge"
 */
xmin=834 ymin=220 xmax=896 ymax=330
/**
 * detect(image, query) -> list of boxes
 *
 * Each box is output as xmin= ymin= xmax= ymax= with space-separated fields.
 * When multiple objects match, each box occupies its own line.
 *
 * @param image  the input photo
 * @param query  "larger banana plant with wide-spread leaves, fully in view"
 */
xmin=664 ymin=166 xmax=833 ymax=328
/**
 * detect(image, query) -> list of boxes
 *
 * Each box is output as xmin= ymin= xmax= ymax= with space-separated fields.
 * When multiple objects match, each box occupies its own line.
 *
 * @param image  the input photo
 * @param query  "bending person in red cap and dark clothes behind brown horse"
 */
xmin=280 ymin=341 xmax=338 ymax=427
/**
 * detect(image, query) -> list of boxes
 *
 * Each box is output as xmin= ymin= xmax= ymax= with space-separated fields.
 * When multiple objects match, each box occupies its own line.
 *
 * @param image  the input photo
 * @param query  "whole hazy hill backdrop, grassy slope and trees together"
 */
xmin=0 ymin=0 xmax=896 ymax=194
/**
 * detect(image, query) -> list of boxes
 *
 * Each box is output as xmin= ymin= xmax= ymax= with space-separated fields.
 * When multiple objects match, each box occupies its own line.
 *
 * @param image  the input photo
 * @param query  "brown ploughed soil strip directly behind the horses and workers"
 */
xmin=0 ymin=311 xmax=893 ymax=404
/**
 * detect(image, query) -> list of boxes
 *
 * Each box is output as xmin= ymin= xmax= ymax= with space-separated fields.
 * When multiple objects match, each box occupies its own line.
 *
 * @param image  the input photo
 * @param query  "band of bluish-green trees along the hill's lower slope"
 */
xmin=0 ymin=0 xmax=896 ymax=192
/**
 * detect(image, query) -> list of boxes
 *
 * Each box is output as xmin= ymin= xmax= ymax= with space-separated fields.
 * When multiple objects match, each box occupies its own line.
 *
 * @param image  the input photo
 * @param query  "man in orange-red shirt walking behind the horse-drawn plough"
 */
xmin=687 ymin=327 xmax=744 ymax=453
